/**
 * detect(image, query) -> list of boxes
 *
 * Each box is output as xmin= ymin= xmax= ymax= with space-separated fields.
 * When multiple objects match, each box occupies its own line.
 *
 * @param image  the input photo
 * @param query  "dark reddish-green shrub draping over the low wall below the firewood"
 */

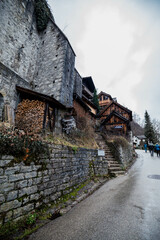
xmin=0 ymin=126 xmax=49 ymax=161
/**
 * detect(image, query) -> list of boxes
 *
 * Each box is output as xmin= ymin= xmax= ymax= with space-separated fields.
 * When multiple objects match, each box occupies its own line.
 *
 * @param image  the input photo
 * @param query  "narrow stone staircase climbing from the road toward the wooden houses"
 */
xmin=96 ymin=134 xmax=125 ymax=176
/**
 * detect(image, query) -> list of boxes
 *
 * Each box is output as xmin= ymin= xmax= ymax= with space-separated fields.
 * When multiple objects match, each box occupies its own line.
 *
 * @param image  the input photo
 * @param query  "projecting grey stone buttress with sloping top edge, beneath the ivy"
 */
xmin=35 ymin=21 xmax=75 ymax=107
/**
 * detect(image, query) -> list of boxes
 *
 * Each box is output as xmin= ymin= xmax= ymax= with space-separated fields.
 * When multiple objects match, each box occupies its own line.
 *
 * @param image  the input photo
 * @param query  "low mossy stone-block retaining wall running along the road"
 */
xmin=0 ymin=145 xmax=108 ymax=224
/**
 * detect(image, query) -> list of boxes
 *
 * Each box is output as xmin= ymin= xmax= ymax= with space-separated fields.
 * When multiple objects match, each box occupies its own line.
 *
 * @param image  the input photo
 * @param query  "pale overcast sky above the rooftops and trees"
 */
xmin=48 ymin=0 xmax=160 ymax=120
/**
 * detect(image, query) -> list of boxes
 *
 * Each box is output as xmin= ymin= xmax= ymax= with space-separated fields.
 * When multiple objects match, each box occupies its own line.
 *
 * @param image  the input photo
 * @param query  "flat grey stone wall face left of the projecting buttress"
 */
xmin=0 ymin=0 xmax=40 ymax=81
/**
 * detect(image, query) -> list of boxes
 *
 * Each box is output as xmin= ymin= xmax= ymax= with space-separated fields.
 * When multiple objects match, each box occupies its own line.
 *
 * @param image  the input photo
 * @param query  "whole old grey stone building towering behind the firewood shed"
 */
xmin=0 ymin=0 xmax=89 ymax=132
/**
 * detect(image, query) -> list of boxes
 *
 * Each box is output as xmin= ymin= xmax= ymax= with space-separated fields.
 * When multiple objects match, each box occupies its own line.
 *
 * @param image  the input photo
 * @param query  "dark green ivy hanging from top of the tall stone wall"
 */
xmin=35 ymin=0 xmax=54 ymax=32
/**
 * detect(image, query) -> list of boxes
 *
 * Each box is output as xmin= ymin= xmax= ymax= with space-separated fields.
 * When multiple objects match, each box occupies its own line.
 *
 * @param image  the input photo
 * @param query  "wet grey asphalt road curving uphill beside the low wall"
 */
xmin=29 ymin=150 xmax=160 ymax=240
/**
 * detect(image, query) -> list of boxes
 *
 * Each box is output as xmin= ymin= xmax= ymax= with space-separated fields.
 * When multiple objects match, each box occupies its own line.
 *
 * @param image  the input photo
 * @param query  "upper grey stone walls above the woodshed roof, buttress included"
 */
xmin=0 ymin=0 xmax=75 ymax=107
